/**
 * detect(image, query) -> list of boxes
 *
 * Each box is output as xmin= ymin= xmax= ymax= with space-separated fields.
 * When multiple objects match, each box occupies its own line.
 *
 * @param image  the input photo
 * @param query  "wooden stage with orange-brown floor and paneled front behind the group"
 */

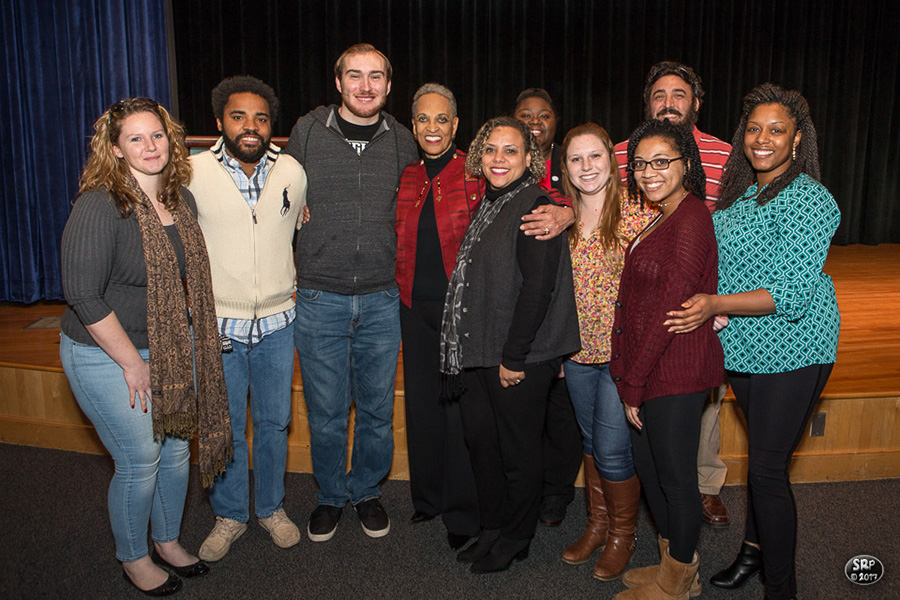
xmin=0 ymin=244 xmax=900 ymax=485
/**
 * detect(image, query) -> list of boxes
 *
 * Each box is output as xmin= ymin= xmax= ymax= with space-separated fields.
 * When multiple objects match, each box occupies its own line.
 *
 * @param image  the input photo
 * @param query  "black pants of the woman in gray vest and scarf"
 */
xmin=460 ymin=361 xmax=559 ymax=540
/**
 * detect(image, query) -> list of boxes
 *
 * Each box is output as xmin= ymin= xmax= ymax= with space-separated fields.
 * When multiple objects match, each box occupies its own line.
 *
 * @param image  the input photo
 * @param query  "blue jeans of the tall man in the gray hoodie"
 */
xmin=294 ymin=288 xmax=400 ymax=506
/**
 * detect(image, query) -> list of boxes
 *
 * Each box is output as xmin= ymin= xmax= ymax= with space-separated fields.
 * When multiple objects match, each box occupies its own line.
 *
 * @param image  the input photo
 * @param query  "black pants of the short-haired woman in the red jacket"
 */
xmin=400 ymin=300 xmax=480 ymax=536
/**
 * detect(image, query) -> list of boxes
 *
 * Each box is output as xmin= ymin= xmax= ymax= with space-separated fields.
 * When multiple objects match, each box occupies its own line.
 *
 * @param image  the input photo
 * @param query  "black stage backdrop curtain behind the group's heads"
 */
xmin=173 ymin=0 xmax=900 ymax=244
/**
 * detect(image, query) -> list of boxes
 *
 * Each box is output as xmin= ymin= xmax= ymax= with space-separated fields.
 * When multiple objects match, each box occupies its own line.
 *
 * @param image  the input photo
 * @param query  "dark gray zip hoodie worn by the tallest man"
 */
xmin=284 ymin=105 xmax=418 ymax=295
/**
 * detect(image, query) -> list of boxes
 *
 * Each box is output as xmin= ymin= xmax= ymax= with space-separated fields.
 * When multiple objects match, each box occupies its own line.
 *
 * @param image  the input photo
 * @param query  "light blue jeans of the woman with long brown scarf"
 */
xmin=59 ymin=334 xmax=190 ymax=562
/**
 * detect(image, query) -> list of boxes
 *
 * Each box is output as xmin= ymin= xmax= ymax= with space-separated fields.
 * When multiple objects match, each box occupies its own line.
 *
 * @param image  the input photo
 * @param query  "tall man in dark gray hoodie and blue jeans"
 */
xmin=285 ymin=44 xmax=418 ymax=542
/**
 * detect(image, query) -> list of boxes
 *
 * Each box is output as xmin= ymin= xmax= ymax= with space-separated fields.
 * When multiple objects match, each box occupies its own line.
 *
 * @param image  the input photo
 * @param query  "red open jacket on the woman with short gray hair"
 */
xmin=395 ymin=150 xmax=484 ymax=306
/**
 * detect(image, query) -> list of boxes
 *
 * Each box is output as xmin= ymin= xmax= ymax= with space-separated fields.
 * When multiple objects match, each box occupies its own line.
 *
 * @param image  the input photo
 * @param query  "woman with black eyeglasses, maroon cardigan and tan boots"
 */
xmin=610 ymin=119 xmax=723 ymax=600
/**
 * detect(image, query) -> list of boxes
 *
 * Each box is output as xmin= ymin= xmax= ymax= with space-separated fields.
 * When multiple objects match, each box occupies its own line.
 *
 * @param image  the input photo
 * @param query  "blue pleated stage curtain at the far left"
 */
xmin=0 ymin=0 xmax=170 ymax=302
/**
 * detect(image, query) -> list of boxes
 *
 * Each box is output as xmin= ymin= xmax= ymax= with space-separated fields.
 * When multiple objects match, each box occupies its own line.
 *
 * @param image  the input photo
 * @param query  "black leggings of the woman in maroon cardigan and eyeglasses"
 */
xmin=631 ymin=391 xmax=707 ymax=563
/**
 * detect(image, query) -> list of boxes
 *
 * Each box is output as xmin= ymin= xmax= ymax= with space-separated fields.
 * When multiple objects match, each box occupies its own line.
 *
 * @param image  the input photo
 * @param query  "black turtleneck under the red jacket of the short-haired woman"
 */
xmin=412 ymin=144 xmax=462 ymax=302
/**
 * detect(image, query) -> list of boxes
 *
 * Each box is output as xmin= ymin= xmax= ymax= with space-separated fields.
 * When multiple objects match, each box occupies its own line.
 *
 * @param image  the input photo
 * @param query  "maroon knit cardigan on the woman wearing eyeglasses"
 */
xmin=610 ymin=194 xmax=724 ymax=406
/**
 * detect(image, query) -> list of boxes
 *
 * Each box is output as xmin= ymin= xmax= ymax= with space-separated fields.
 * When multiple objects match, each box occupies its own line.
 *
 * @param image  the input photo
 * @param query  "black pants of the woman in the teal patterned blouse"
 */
xmin=728 ymin=364 xmax=834 ymax=600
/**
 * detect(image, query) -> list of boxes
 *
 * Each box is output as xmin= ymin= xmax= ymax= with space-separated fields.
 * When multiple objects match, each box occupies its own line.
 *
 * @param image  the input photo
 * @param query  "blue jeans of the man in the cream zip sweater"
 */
xmin=209 ymin=327 xmax=294 ymax=523
